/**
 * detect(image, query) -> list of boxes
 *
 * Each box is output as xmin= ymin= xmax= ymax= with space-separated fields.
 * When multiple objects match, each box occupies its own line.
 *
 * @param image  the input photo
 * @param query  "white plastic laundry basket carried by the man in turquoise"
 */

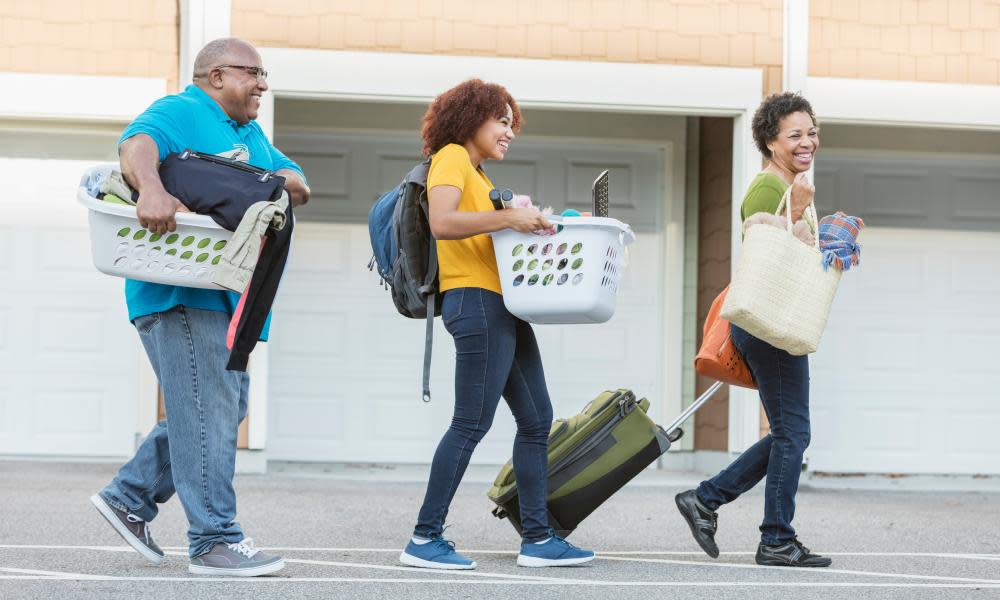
xmin=77 ymin=165 xmax=233 ymax=290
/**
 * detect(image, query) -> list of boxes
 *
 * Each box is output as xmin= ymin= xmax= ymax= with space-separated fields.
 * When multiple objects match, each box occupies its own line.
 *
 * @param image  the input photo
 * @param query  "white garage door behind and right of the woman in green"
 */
xmin=809 ymin=155 xmax=1000 ymax=474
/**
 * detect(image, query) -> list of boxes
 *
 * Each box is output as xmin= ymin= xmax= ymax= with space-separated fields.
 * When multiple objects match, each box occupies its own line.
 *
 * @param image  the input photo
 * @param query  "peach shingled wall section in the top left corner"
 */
xmin=0 ymin=0 xmax=178 ymax=90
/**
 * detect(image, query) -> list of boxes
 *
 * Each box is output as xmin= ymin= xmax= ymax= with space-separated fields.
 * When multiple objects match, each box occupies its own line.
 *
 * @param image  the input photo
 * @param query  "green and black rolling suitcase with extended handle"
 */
xmin=487 ymin=383 xmax=722 ymax=537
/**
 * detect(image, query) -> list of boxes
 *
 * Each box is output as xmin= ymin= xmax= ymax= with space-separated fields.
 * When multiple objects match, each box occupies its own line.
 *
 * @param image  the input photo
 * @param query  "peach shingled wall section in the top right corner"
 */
xmin=809 ymin=0 xmax=1000 ymax=85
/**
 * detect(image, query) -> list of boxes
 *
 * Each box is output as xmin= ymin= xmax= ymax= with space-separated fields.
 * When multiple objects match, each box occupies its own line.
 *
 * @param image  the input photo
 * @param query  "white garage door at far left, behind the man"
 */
xmin=0 ymin=131 xmax=140 ymax=456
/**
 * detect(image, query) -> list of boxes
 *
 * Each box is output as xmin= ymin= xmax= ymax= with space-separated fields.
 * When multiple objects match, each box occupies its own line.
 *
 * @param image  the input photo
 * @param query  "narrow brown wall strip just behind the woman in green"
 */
xmin=694 ymin=117 xmax=733 ymax=450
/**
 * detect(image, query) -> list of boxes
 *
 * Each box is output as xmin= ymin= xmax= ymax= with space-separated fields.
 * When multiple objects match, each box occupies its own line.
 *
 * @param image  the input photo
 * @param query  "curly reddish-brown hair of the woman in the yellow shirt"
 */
xmin=420 ymin=79 xmax=524 ymax=156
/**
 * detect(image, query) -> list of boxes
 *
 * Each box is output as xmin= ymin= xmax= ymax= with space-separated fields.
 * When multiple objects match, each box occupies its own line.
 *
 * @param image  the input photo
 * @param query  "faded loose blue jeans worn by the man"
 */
xmin=101 ymin=306 xmax=250 ymax=557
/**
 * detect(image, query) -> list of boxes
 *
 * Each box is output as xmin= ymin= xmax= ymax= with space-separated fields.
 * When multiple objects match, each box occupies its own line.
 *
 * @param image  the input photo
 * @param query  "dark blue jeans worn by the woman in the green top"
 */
xmin=698 ymin=325 xmax=810 ymax=545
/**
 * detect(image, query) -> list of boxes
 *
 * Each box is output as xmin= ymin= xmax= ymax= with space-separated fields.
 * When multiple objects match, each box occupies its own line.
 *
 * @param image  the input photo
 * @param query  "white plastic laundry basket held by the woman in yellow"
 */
xmin=492 ymin=217 xmax=635 ymax=323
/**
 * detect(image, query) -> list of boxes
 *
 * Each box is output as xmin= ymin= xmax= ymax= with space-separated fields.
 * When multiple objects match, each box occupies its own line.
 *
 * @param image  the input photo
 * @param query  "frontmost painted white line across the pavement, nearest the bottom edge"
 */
xmin=0 ymin=575 xmax=1000 ymax=589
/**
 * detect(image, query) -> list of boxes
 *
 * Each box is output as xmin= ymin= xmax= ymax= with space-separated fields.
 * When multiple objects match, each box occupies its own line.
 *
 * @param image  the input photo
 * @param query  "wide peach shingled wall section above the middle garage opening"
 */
xmin=232 ymin=0 xmax=782 ymax=92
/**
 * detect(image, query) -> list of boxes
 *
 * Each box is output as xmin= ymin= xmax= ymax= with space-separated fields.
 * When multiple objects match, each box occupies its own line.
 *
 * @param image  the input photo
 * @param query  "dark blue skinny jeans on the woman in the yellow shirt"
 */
xmin=413 ymin=288 xmax=552 ymax=542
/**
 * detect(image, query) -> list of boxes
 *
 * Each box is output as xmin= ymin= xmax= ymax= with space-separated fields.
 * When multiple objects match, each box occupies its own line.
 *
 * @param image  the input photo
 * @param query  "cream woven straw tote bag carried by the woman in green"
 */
xmin=722 ymin=186 xmax=841 ymax=356
